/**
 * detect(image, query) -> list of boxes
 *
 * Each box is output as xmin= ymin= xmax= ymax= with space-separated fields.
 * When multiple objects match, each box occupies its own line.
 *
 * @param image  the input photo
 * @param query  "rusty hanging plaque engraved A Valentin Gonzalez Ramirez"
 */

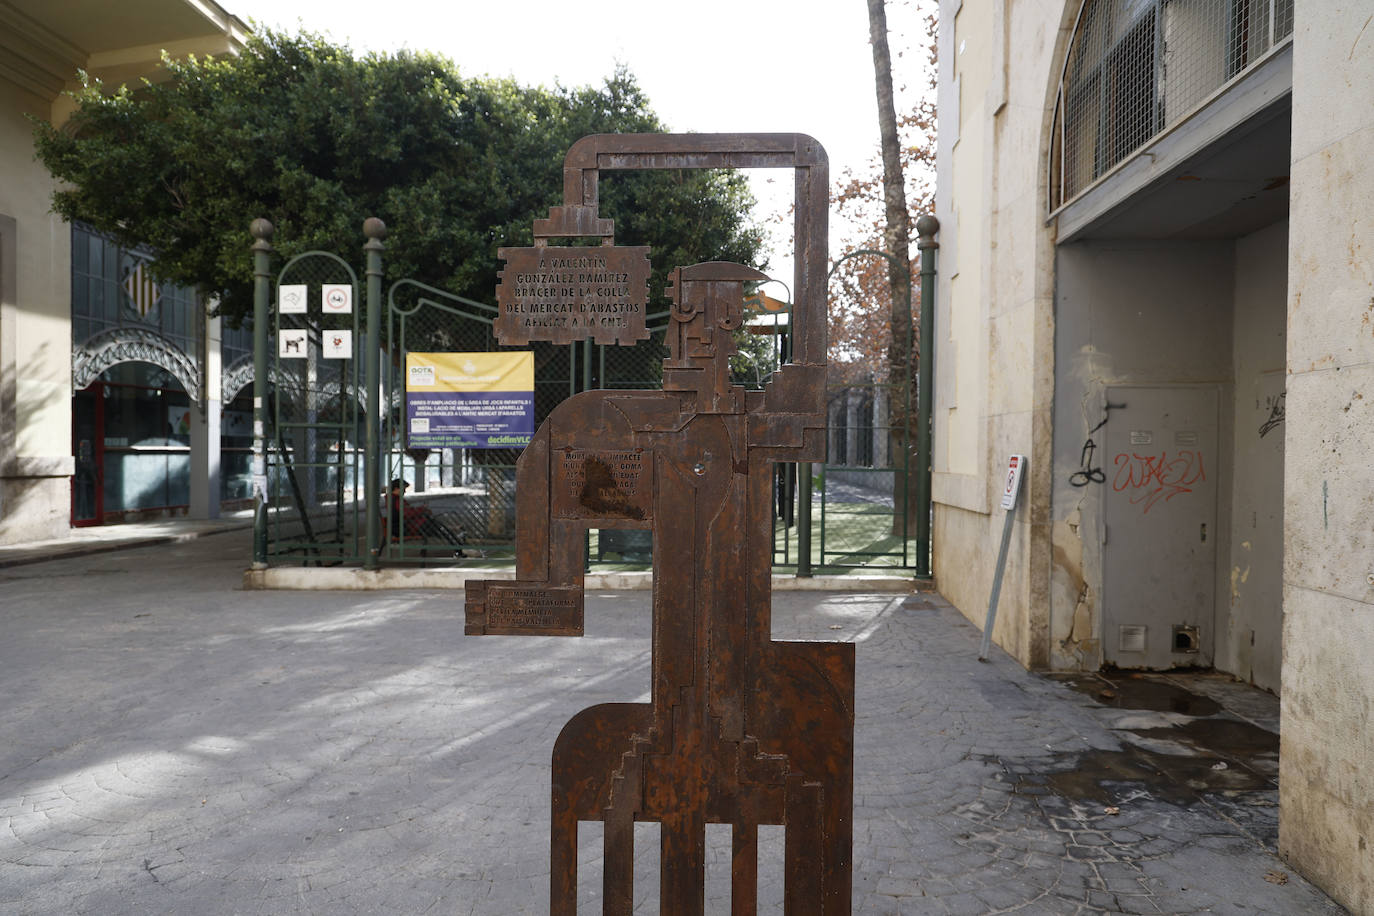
xmin=495 ymin=244 xmax=650 ymax=346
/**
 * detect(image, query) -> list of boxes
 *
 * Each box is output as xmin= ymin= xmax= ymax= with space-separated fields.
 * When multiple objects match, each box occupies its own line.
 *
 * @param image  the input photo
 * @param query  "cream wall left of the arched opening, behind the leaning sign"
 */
xmin=932 ymin=0 xmax=1072 ymax=666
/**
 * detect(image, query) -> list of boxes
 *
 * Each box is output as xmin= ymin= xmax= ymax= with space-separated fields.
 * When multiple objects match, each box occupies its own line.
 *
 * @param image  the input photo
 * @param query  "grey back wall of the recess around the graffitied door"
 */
xmin=1050 ymin=239 xmax=1235 ymax=670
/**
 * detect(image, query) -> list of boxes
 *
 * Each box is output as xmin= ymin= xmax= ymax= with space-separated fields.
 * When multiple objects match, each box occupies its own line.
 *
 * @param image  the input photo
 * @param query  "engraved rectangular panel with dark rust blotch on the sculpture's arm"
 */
xmin=552 ymin=448 xmax=654 ymax=522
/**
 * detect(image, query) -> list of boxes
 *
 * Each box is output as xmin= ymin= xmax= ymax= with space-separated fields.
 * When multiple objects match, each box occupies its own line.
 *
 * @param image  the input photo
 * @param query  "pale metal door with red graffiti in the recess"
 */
xmin=1102 ymin=387 xmax=1220 ymax=669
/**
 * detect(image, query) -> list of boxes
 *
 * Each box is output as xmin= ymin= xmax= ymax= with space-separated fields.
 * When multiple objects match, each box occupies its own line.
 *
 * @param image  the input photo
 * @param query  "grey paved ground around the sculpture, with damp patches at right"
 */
xmin=0 ymin=531 xmax=1342 ymax=916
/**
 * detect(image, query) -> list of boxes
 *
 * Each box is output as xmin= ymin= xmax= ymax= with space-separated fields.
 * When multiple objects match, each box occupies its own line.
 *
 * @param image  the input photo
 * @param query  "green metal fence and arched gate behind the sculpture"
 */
xmin=254 ymin=222 xmax=919 ymax=571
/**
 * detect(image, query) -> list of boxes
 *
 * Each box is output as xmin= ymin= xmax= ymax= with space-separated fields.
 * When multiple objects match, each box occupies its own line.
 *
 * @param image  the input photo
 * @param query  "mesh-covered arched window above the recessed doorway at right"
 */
xmin=1050 ymin=0 xmax=1294 ymax=209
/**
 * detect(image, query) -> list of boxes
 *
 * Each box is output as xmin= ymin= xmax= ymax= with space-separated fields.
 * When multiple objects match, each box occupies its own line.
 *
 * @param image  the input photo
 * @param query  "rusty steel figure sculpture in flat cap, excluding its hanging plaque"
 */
xmin=466 ymin=135 xmax=855 ymax=915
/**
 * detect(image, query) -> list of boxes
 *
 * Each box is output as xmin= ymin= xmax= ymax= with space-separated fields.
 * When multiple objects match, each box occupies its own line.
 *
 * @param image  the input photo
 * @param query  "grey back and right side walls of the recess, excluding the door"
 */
xmin=1050 ymin=221 xmax=1287 ymax=689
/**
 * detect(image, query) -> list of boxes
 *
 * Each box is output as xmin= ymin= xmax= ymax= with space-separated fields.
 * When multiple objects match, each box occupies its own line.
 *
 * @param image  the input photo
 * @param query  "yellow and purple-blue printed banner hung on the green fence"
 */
xmin=405 ymin=350 xmax=534 ymax=449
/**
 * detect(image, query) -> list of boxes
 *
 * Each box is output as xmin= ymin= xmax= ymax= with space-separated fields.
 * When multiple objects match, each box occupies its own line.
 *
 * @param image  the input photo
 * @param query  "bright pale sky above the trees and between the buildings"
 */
xmin=220 ymin=0 xmax=921 ymax=289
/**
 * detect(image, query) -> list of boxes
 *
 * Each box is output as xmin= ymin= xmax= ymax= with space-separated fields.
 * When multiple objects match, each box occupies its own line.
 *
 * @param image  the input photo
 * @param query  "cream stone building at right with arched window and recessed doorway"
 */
xmin=933 ymin=0 xmax=1374 ymax=912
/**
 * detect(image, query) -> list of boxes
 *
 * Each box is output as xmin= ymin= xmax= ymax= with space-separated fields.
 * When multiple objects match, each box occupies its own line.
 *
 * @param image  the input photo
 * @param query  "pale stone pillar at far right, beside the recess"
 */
xmin=1279 ymin=3 xmax=1374 ymax=913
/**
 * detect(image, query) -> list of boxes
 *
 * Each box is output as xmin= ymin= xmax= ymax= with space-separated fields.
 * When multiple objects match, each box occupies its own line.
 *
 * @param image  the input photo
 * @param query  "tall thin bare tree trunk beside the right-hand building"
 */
xmin=868 ymin=0 xmax=915 ymax=534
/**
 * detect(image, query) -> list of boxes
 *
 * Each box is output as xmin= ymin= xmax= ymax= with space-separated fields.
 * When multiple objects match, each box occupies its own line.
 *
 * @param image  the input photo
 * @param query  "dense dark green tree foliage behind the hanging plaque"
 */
xmin=36 ymin=32 xmax=761 ymax=323
